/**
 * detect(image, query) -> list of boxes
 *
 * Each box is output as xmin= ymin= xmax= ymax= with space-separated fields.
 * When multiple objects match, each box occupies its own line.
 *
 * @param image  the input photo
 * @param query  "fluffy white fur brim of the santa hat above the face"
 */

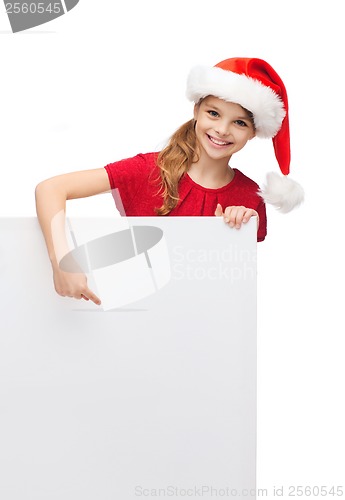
xmin=186 ymin=66 xmax=286 ymax=139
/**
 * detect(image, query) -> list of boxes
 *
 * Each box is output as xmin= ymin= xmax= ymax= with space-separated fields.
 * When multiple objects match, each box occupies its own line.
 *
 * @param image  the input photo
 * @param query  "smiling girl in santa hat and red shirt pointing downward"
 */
xmin=36 ymin=58 xmax=303 ymax=304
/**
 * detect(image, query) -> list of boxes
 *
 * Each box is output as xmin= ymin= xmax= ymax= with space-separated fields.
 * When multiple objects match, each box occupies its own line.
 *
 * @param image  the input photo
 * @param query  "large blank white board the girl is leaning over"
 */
xmin=0 ymin=217 xmax=256 ymax=500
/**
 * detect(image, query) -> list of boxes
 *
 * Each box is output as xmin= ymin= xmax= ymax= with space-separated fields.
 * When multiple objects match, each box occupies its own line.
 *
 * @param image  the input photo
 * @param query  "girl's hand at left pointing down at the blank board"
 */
xmin=53 ymin=268 xmax=101 ymax=305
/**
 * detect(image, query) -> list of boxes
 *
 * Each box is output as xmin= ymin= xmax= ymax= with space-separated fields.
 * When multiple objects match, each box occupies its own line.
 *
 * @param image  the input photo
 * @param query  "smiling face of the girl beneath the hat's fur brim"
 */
xmin=194 ymin=96 xmax=255 ymax=160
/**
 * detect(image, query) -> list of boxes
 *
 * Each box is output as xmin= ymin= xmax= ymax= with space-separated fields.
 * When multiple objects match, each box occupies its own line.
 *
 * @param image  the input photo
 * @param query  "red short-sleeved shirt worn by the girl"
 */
xmin=105 ymin=153 xmax=267 ymax=241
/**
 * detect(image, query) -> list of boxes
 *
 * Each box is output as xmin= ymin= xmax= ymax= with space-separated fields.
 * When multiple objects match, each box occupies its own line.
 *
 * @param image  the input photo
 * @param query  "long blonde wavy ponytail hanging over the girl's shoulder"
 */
xmin=156 ymin=119 xmax=197 ymax=215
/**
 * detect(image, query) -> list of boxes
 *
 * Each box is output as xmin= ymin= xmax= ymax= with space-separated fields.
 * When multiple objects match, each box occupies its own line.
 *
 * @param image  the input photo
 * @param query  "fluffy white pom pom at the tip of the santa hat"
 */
xmin=260 ymin=172 xmax=304 ymax=213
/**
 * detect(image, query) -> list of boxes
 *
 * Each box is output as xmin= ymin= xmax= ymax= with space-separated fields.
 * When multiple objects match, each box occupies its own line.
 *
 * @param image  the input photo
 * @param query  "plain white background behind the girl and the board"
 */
xmin=0 ymin=0 xmax=345 ymax=498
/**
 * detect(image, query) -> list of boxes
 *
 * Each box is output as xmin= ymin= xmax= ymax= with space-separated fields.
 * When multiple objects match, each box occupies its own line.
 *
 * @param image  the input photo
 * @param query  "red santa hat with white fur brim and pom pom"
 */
xmin=187 ymin=57 xmax=304 ymax=212
